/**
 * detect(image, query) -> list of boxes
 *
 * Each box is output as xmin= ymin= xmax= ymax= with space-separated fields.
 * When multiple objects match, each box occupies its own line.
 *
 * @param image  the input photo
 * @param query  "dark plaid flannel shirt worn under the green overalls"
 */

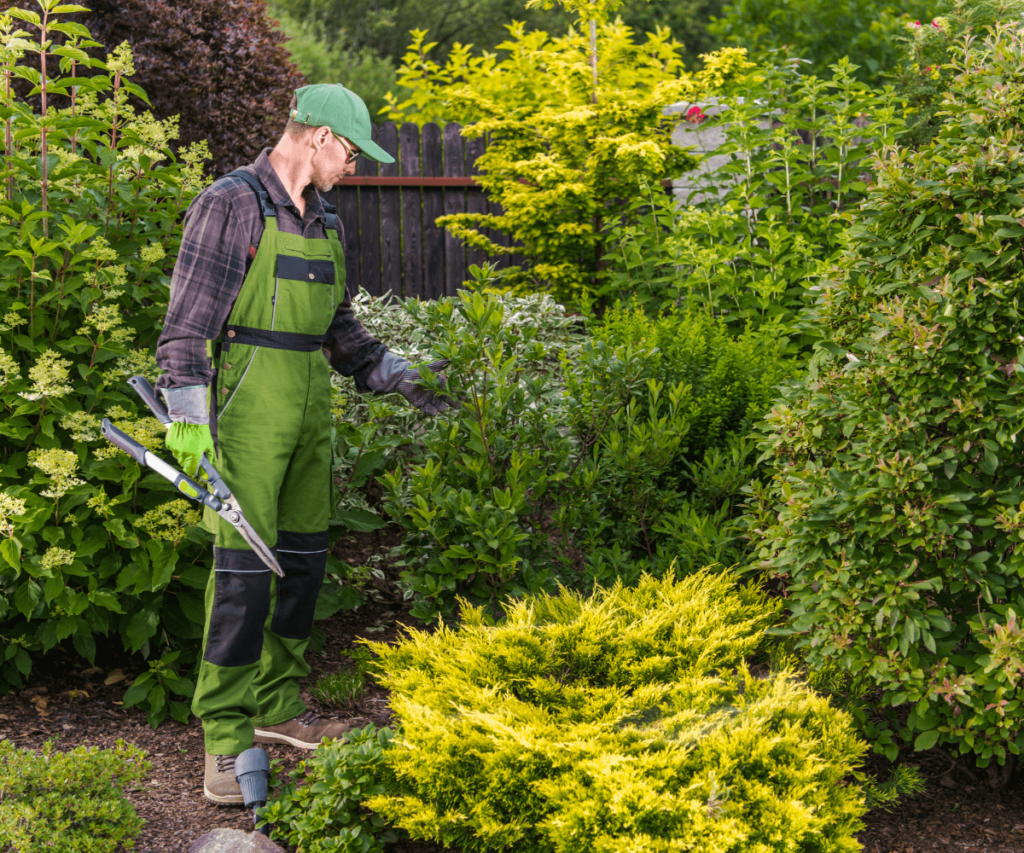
xmin=157 ymin=148 xmax=387 ymax=392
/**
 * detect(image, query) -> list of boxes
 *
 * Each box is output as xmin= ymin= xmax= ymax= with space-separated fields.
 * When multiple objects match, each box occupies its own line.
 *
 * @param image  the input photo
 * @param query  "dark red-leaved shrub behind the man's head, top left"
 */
xmin=73 ymin=0 xmax=305 ymax=176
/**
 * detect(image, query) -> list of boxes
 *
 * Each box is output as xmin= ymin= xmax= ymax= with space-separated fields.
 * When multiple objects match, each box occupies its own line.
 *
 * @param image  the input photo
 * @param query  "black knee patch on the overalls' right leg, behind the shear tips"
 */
xmin=270 ymin=530 xmax=330 ymax=640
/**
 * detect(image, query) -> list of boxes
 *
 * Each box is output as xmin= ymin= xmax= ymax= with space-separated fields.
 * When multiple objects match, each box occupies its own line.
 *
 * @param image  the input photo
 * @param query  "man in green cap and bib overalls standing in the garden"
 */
xmin=157 ymin=84 xmax=447 ymax=804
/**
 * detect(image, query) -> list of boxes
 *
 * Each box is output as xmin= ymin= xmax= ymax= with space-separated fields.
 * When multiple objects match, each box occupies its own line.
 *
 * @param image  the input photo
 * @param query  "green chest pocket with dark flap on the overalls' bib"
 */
xmin=270 ymin=255 xmax=335 ymax=335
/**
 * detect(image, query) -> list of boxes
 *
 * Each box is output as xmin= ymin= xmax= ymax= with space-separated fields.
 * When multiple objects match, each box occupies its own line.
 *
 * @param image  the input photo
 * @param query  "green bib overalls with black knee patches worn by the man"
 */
xmin=191 ymin=170 xmax=345 ymax=755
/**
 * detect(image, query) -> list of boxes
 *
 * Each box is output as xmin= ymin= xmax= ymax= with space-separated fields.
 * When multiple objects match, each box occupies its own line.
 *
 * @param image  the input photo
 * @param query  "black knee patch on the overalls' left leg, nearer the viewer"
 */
xmin=203 ymin=548 xmax=270 ymax=667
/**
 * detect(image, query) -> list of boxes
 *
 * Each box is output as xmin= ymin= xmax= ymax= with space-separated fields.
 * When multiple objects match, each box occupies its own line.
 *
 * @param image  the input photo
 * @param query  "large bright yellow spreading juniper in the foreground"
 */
xmin=366 ymin=572 xmax=865 ymax=853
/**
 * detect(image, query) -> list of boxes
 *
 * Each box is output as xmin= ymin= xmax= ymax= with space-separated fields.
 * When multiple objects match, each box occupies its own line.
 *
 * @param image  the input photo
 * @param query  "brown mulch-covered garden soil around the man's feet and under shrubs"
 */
xmin=0 ymin=534 xmax=1024 ymax=853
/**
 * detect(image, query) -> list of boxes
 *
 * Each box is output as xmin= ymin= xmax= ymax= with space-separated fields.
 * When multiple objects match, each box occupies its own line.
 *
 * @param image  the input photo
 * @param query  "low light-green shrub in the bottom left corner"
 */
xmin=0 ymin=740 xmax=151 ymax=853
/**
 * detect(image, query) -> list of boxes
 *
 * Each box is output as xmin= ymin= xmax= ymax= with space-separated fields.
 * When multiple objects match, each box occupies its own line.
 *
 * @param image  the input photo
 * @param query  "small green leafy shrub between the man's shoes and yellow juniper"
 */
xmin=259 ymin=723 xmax=396 ymax=853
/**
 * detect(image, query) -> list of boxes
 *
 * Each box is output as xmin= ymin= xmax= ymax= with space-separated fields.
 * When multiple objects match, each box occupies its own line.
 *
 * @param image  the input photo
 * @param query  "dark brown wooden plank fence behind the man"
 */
xmin=328 ymin=122 xmax=521 ymax=299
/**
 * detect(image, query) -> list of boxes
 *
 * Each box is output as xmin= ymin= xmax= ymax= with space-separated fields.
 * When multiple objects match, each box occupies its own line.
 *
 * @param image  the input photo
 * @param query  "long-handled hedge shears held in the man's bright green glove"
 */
xmin=101 ymin=376 xmax=285 ymax=578
